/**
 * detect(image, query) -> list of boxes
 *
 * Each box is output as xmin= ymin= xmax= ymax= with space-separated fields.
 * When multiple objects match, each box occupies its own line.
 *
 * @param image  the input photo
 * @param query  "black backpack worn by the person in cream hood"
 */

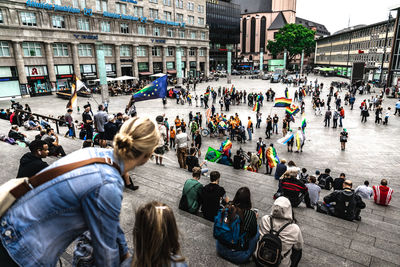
xmin=256 ymin=219 xmax=292 ymax=266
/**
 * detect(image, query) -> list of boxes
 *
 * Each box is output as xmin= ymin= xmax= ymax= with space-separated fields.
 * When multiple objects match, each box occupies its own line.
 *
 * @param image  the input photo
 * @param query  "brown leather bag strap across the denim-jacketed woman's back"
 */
xmin=10 ymin=158 xmax=121 ymax=199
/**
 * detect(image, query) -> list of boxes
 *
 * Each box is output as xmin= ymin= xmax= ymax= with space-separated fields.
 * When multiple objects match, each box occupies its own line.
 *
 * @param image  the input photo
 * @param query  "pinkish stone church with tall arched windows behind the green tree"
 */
xmin=235 ymin=0 xmax=329 ymax=69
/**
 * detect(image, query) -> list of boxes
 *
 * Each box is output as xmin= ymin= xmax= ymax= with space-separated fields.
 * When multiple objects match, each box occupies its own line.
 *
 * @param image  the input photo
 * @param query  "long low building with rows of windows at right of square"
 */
xmin=315 ymin=19 xmax=395 ymax=81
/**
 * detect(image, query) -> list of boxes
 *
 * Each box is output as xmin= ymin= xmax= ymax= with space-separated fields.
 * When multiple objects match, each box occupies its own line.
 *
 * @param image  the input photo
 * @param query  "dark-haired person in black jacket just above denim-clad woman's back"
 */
xmin=17 ymin=140 xmax=49 ymax=178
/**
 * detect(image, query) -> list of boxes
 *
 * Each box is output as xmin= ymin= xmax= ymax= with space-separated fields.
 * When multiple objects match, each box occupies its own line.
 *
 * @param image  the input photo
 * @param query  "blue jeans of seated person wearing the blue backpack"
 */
xmin=217 ymin=232 xmax=260 ymax=264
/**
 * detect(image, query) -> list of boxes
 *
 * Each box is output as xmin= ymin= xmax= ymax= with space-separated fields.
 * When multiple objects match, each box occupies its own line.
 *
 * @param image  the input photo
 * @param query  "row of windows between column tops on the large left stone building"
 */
xmin=0 ymin=41 xmax=205 ymax=57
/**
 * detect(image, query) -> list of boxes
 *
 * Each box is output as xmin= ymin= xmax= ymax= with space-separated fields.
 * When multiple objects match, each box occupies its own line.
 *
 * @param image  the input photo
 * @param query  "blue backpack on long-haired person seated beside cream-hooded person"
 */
xmin=213 ymin=208 xmax=246 ymax=250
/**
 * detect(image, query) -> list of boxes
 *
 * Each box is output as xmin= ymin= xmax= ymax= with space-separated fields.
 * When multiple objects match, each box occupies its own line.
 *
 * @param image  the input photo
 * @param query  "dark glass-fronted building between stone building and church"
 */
xmin=206 ymin=0 xmax=240 ymax=70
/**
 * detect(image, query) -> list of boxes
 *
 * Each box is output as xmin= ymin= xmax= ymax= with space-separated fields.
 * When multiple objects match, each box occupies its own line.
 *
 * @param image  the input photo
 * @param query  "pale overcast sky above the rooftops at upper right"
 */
xmin=296 ymin=0 xmax=400 ymax=34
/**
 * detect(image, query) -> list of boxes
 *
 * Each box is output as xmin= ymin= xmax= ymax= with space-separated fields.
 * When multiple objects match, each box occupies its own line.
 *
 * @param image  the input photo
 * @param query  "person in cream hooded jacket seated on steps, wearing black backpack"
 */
xmin=254 ymin=197 xmax=304 ymax=267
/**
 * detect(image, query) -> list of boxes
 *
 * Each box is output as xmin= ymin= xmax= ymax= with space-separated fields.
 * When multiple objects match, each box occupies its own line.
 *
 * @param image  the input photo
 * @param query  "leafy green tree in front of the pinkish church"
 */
xmin=267 ymin=24 xmax=315 ymax=65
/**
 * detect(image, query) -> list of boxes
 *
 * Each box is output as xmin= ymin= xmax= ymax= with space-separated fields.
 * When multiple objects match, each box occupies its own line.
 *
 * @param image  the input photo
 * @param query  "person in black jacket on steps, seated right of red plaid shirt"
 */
xmin=324 ymin=180 xmax=365 ymax=221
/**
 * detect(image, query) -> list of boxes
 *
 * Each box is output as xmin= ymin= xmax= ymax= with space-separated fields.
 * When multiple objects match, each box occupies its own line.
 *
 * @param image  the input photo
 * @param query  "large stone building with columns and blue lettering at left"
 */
xmin=0 ymin=0 xmax=209 ymax=97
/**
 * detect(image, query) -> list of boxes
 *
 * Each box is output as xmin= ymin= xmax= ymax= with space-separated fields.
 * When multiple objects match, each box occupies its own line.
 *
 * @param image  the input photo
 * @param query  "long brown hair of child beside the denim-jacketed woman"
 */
xmin=131 ymin=201 xmax=185 ymax=267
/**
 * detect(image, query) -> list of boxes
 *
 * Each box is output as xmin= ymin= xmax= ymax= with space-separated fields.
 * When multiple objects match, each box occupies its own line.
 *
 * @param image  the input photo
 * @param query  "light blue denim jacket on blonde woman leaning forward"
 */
xmin=0 ymin=148 xmax=128 ymax=266
